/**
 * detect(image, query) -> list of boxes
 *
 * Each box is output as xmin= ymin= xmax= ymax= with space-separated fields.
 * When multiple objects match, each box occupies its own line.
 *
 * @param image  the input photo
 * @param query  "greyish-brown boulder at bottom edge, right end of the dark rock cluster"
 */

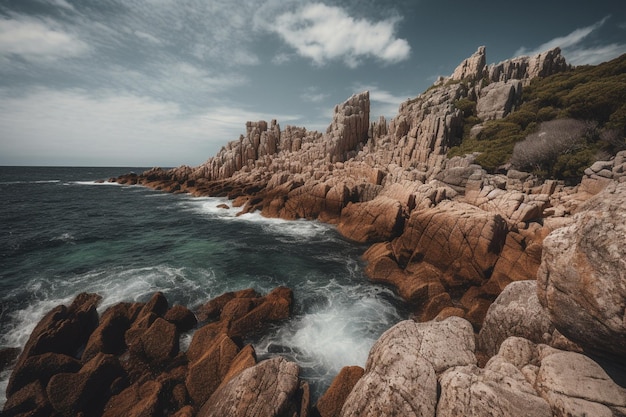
xmin=197 ymin=357 xmax=301 ymax=417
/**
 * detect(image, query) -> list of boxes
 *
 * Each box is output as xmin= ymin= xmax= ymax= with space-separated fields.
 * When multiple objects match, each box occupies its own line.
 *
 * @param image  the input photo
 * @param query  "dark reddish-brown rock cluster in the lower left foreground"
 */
xmin=2 ymin=287 xmax=300 ymax=417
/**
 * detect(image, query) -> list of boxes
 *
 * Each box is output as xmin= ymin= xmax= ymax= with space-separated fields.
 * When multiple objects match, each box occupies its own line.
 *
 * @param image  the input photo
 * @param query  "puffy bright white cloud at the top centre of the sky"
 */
xmin=267 ymin=3 xmax=411 ymax=68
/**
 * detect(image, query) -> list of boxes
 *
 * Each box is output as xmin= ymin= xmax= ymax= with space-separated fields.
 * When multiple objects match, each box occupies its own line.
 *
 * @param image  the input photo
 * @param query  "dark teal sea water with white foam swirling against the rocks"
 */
xmin=0 ymin=167 xmax=405 ymax=409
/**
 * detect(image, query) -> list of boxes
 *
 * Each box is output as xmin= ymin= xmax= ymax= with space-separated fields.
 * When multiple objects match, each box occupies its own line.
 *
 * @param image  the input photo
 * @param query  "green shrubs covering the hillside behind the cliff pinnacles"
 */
xmin=448 ymin=55 xmax=626 ymax=182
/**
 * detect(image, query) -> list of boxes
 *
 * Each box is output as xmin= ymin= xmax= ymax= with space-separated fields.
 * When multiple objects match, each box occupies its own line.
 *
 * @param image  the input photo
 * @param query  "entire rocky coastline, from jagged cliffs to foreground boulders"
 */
xmin=3 ymin=47 xmax=626 ymax=417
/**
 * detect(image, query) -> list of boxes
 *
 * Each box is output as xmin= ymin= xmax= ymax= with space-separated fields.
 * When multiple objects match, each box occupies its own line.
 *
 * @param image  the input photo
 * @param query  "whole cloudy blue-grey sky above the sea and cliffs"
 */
xmin=0 ymin=0 xmax=626 ymax=166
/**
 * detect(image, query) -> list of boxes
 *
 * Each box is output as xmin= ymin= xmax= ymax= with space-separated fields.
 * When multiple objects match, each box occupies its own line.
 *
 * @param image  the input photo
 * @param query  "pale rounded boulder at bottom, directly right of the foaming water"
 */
xmin=341 ymin=317 xmax=476 ymax=417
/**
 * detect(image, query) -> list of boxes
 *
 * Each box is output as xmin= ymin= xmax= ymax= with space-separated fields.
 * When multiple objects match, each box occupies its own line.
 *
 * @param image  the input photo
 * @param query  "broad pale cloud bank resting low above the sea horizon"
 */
xmin=0 ymin=89 xmax=299 ymax=166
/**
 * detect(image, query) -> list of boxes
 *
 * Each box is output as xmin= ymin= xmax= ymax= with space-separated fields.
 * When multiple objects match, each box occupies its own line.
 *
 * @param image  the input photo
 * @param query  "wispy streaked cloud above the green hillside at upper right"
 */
xmin=514 ymin=16 xmax=626 ymax=65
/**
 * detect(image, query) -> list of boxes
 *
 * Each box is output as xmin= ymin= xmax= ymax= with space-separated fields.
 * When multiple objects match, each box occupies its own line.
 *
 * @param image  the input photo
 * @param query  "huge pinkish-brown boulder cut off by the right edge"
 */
xmin=537 ymin=183 xmax=626 ymax=364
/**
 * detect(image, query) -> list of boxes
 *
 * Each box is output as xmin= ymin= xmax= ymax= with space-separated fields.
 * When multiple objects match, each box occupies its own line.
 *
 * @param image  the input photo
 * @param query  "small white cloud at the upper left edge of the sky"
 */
xmin=0 ymin=15 xmax=89 ymax=62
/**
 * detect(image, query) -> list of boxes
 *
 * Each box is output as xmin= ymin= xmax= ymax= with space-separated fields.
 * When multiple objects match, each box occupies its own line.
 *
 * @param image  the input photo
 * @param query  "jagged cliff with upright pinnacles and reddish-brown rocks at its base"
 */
xmin=107 ymin=47 xmax=600 ymax=330
